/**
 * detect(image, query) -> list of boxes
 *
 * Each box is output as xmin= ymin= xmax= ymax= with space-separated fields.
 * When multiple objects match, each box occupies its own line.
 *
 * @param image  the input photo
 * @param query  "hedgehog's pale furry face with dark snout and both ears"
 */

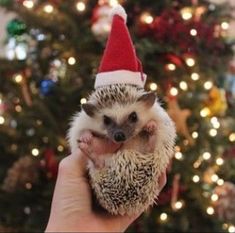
xmin=82 ymin=93 xmax=156 ymax=143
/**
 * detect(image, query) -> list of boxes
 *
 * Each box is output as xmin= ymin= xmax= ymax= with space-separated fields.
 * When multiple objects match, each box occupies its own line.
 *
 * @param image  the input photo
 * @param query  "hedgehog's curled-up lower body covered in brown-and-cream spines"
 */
xmin=89 ymin=150 xmax=163 ymax=215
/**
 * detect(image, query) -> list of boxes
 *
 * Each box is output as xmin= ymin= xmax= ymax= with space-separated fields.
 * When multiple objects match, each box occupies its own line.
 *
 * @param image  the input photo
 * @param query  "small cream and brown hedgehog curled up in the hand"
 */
xmin=68 ymin=84 xmax=176 ymax=215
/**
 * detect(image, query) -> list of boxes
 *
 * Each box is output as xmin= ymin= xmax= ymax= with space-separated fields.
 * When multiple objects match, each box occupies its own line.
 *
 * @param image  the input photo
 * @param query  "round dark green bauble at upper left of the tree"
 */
xmin=7 ymin=19 xmax=27 ymax=36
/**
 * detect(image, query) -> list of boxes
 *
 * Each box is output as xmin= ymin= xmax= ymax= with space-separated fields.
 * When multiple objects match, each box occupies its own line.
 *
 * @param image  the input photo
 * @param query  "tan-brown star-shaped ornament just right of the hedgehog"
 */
xmin=167 ymin=96 xmax=194 ymax=144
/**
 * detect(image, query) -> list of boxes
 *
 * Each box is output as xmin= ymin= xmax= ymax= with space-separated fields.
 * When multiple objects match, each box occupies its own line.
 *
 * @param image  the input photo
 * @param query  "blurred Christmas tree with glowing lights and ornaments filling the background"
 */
xmin=0 ymin=0 xmax=235 ymax=232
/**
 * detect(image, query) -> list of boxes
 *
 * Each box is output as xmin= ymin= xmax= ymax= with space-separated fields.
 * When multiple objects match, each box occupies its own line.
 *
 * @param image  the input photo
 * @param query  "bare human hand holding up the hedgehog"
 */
xmin=46 ymin=137 xmax=166 ymax=232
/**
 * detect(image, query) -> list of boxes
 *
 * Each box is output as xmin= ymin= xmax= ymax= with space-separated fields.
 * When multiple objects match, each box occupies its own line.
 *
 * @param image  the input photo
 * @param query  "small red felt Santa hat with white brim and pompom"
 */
xmin=95 ymin=5 xmax=147 ymax=88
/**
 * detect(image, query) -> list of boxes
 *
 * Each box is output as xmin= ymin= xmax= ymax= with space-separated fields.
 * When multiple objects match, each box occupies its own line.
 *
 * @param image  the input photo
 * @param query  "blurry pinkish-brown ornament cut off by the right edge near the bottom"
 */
xmin=213 ymin=182 xmax=235 ymax=224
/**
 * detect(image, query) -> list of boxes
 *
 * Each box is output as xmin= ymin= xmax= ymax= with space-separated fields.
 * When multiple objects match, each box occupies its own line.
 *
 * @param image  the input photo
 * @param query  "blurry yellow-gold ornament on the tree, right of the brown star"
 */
xmin=206 ymin=86 xmax=227 ymax=116
